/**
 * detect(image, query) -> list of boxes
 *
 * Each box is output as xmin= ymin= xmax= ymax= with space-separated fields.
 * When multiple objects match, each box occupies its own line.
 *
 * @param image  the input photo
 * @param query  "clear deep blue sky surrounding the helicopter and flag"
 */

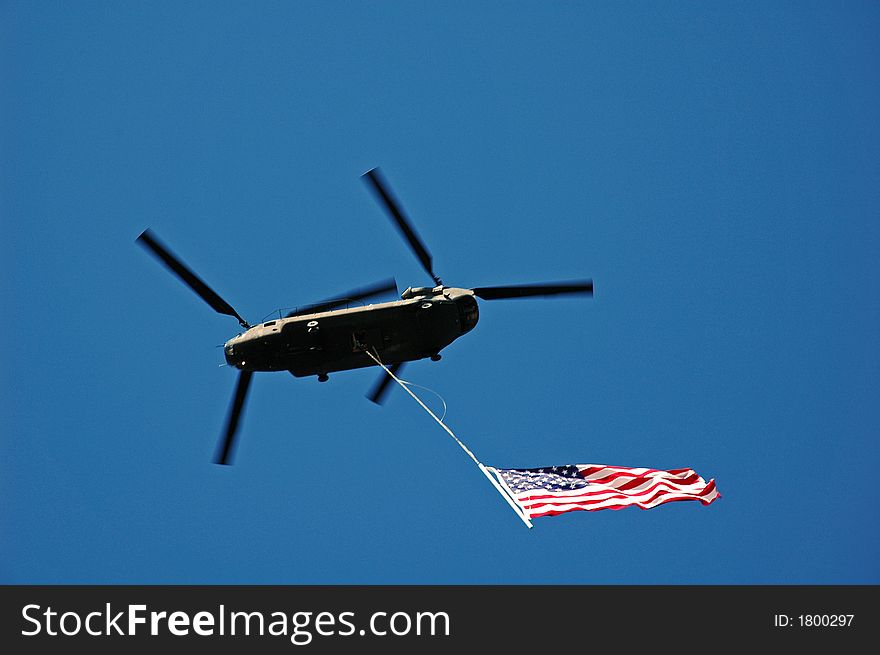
xmin=0 ymin=2 xmax=880 ymax=584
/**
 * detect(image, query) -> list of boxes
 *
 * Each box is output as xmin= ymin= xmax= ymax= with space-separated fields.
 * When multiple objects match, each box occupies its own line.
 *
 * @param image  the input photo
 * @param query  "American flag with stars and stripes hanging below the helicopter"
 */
xmin=493 ymin=464 xmax=721 ymax=518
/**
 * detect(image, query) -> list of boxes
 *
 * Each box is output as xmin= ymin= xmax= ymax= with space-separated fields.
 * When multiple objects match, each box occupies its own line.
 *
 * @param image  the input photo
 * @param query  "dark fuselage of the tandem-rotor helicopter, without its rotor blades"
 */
xmin=223 ymin=287 xmax=479 ymax=379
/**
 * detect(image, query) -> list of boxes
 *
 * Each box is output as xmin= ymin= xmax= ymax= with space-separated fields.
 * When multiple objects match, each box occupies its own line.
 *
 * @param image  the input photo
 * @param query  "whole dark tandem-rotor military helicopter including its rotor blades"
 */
xmin=136 ymin=168 xmax=593 ymax=465
